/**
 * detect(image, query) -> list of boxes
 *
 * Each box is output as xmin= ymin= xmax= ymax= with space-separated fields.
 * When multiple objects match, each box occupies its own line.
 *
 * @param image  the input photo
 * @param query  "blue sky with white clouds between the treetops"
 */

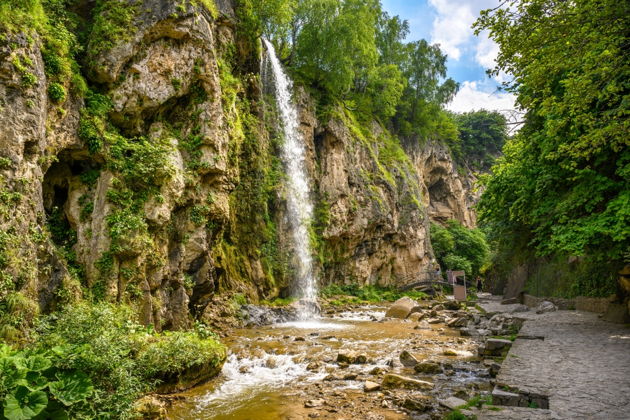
xmin=381 ymin=0 xmax=514 ymax=112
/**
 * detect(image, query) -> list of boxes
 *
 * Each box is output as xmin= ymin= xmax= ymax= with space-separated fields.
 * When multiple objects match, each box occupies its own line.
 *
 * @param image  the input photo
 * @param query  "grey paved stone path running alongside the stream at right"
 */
xmin=478 ymin=296 xmax=630 ymax=420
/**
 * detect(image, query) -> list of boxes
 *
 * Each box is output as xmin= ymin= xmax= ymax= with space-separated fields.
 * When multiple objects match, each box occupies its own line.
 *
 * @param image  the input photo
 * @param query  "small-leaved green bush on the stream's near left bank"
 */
xmin=29 ymin=303 xmax=226 ymax=419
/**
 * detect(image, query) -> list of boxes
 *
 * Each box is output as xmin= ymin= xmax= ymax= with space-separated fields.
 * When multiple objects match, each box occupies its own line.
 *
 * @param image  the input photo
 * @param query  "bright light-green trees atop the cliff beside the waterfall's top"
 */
xmin=244 ymin=0 xmax=458 ymax=140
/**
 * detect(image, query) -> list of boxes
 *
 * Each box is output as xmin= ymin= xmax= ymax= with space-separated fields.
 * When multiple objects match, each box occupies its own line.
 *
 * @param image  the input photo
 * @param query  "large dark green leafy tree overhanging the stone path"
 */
xmin=475 ymin=0 xmax=630 ymax=271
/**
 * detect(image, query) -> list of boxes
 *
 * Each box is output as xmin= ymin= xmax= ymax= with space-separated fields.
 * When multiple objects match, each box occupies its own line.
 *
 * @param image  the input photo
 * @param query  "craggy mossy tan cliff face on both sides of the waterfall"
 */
xmin=0 ymin=0 xmax=475 ymax=329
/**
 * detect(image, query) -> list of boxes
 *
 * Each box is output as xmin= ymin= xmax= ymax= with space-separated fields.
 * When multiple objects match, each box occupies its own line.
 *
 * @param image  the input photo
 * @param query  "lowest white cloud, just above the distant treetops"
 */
xmin=446 ymin=82 xmax=515 ymax=112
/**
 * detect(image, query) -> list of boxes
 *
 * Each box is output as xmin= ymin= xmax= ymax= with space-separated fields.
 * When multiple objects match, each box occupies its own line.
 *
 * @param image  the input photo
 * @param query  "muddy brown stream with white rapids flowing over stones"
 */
xmin=169 ymin=307 xmax=489 ymax=420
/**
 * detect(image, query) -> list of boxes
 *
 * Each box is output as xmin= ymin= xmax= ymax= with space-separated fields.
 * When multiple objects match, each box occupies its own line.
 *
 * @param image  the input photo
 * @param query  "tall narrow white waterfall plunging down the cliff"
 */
xmin=261 ymin=39 xmax=318 ymax=320
